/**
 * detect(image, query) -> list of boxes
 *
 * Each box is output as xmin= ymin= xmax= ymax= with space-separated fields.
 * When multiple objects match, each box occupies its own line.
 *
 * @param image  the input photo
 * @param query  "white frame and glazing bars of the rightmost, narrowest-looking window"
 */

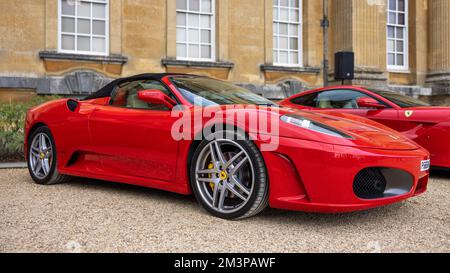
xmin=386 ymin=0 xmax=409 ymax=72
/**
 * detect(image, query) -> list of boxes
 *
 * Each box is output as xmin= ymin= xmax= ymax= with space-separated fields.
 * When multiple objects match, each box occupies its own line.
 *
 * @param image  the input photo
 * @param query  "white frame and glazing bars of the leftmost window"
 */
xmin=58 ymin=0 xmax=110 ymax=56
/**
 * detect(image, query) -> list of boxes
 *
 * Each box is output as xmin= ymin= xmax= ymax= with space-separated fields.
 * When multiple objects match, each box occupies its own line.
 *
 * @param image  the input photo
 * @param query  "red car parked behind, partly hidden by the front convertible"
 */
xmin=280 ymin=86 xmax=450 ymax=169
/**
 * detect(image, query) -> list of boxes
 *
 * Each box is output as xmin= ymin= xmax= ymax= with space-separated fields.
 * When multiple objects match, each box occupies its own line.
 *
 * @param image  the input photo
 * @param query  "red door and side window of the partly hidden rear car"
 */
xmin=316 ymin=89 xmax=398 ymax=130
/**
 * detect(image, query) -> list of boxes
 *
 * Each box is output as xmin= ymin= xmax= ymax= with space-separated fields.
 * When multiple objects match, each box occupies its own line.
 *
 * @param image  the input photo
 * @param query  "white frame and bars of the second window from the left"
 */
xmin=175 ymin=0 xmax=216 ymax=62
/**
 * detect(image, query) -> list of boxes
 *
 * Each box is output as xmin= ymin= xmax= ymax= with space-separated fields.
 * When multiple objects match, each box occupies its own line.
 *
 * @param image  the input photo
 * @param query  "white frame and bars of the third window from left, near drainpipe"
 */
xmin=272 ymin=0 xmax=303 ymax=67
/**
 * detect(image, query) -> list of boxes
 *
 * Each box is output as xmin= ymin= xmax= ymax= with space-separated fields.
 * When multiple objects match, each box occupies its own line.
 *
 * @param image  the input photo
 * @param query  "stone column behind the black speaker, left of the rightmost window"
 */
xmin=330 ymin=0 xmax=387 ymax=85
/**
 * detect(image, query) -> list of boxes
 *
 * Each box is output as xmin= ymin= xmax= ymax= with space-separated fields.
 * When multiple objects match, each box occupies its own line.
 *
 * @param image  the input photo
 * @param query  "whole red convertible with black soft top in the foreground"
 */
xmin=25 ymin=74 xmax=429 ymax=219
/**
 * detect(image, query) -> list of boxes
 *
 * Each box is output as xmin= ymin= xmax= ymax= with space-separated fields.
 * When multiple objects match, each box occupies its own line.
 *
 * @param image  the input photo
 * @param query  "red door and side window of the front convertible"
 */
xmin=89 ymin=77 xmax=178 ymax=182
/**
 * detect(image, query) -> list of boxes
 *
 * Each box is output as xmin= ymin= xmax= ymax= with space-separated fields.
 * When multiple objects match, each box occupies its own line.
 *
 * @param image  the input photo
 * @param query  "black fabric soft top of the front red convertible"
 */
xmin=84 ymin=73 xmax=195 ymax=100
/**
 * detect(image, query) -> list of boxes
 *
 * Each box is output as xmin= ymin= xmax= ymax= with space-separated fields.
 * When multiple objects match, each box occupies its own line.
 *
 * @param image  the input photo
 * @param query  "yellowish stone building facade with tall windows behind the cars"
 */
xmin=0 ymin=0 xmax=450 ymax=101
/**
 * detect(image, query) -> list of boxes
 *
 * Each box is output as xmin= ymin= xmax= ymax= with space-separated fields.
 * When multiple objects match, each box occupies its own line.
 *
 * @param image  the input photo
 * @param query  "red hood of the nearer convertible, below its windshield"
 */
xmin=196 ymin=106 xmax=420 ymax=150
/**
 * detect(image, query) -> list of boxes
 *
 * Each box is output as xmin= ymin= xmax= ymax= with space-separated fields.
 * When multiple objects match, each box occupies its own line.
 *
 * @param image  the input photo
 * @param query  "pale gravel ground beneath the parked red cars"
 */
xmin=0 ymin=169 xmax=450 ymax=252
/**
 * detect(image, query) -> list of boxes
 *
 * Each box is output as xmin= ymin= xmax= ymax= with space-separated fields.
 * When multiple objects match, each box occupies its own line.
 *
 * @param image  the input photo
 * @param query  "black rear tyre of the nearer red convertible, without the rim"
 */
xmin=26 ymin=126 xmax=71 ymax=185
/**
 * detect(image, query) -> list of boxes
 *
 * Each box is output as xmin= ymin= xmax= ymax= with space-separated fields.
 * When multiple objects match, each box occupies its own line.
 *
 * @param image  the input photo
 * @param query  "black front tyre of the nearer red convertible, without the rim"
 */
xmin=190 ymin=131 xmax=269 ymax=220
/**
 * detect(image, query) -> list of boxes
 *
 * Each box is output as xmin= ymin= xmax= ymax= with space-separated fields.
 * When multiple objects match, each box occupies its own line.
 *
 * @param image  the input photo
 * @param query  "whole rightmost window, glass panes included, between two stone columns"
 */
xmin=387 ymin=0 xmax=408 ymax=70
